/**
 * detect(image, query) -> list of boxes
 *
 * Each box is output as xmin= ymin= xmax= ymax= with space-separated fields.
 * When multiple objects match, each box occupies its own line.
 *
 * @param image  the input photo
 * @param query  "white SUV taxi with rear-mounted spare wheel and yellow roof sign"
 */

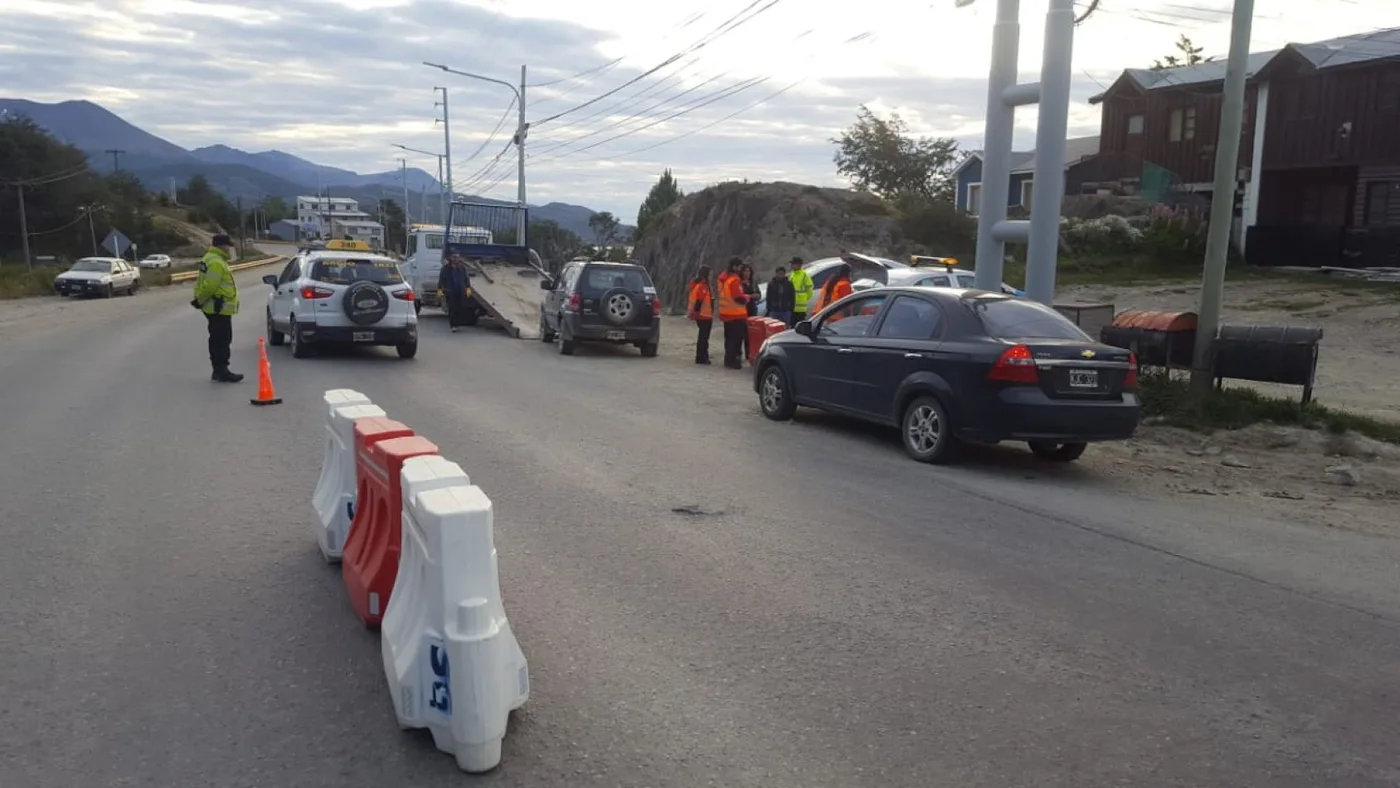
xmin=263 ymin=241 xmax=419 ymax=358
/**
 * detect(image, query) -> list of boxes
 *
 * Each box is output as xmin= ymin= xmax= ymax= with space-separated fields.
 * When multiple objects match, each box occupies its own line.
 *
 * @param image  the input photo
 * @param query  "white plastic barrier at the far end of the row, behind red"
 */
xmin=311 ymin=389 xmax=385 ymax=563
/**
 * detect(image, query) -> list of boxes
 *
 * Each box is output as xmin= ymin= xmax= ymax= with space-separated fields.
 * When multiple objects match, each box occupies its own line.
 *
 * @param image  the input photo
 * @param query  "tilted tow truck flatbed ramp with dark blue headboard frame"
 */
xmin=442 ymin=202 xmax=550 ymax=339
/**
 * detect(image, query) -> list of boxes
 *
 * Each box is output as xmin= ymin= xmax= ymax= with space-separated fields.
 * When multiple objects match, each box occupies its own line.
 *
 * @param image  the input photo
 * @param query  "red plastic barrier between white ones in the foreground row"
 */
xmin=340 ymin=418 xmax=438 ymax=627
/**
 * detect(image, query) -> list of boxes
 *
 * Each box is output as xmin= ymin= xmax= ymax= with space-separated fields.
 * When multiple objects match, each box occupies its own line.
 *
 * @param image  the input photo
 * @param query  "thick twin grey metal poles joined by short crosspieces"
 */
xmin=955 ymin=0 xmax=1075 ymax=305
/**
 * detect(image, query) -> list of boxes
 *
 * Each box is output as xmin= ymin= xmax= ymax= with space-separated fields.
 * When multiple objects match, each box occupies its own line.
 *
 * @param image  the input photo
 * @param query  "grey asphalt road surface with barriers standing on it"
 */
xmin=0 ymin=270 xmax=1400 ymax=788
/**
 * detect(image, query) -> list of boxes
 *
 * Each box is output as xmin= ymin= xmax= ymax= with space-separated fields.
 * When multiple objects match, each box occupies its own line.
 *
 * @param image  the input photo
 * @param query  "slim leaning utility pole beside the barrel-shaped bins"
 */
xmin=1191 ymin=0 xmax=1254 ymax=407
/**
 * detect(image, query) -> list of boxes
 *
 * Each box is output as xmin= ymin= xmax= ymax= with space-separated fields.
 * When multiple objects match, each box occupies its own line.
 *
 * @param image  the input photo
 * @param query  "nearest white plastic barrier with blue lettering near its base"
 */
xmin=381 ymin=456 xmax=529 ymax=773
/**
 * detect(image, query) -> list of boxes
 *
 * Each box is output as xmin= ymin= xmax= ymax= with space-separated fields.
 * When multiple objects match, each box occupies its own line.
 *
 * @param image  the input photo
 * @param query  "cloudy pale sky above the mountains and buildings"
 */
xmin=0 ymin=0 xmax=1393 ymax=220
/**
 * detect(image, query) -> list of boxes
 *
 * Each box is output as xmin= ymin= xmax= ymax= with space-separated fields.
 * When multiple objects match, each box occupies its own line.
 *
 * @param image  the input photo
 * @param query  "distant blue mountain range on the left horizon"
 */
xmin=0 ymin=98 xmax=616 ymax=238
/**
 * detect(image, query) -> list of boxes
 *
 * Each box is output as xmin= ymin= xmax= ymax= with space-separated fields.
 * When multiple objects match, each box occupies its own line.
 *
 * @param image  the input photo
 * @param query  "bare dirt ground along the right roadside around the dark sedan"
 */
xmin=641 ymin=283 xmax=1400 ymax=537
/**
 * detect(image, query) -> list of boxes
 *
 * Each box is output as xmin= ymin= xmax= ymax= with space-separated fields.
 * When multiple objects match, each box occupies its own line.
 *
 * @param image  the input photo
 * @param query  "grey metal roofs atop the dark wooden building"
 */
xmin=1089 ymin=28 xmax=1400 ymax=104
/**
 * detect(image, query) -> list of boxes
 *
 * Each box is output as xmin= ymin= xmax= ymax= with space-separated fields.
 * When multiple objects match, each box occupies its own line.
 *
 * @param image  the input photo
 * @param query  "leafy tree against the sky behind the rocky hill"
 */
xmin=832 ymin=105 xmax=958 ymax=202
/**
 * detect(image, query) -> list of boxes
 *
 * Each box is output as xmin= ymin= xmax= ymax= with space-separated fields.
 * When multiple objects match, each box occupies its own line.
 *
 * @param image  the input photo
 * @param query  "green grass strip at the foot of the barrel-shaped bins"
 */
xmin=1138 ymin=371 xmax=1400 ymax=444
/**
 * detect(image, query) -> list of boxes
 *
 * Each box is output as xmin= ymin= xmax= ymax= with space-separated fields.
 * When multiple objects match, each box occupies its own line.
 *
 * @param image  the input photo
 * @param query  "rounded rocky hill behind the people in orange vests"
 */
xmin=634 ymin=182 xmax=920 ymax=309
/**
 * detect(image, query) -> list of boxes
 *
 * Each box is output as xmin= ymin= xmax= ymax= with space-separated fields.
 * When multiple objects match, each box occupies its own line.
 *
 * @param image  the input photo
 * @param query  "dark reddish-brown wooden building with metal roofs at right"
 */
xmin=1091 ymin=28 xmax=1400 ymax=266
